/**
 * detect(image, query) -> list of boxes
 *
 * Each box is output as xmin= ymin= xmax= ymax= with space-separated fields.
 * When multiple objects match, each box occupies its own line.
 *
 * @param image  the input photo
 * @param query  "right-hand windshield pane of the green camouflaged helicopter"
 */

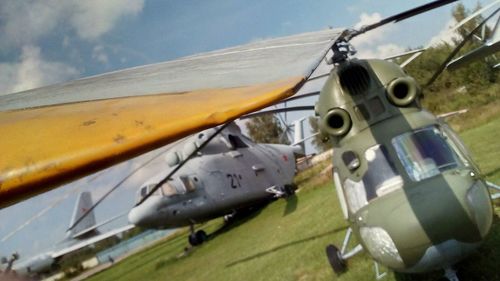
xmin=392 ymin=126 xmax=461 ymax=181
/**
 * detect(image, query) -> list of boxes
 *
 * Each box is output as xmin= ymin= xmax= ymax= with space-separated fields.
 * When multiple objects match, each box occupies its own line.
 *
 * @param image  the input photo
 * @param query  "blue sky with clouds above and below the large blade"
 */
xmin=0 ymin=0 xmax=489 ymax=258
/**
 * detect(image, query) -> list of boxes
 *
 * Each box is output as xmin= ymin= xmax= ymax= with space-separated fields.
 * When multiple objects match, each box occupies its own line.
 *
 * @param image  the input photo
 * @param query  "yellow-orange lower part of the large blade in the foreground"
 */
xmin=0 ymin=77 xmax=305 ymax=208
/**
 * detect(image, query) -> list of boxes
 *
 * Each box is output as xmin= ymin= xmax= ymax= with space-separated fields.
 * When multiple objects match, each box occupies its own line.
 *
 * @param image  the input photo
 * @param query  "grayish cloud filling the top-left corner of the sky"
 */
xmin=0 ymin=0 xmax=144 ymax=49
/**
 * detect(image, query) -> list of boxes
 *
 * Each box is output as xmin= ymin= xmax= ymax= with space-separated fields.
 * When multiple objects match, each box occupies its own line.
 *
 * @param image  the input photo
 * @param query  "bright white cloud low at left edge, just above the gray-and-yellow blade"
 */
xmin=0 ymin=46 xmax=79 ymax=94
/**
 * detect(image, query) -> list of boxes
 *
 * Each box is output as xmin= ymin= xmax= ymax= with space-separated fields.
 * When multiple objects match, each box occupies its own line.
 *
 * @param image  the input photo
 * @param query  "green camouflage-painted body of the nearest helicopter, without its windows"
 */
xmin=316 ymin=59 xmax=492 ymax=272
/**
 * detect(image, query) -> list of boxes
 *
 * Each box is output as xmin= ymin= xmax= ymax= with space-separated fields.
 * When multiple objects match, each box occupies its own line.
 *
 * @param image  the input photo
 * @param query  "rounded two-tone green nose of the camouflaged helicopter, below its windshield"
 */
xmin=384 ymin=175 xmax=491 ymax=273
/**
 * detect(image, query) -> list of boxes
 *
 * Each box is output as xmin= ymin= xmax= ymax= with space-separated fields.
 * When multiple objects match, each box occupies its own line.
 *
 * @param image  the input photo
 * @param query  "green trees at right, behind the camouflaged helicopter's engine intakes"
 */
xmin=405 ymin=4 xmax=500 ymax=129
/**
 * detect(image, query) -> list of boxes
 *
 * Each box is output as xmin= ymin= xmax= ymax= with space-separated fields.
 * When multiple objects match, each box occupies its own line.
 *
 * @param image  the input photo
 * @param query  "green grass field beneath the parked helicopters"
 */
xmin=89 ymin=117 xmax=500 ymax=281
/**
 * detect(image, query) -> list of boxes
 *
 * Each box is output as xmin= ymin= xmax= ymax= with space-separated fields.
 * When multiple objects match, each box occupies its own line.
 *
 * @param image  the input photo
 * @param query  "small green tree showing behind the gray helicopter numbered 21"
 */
xmin=246 ymin=114 xmax=290 ymax=144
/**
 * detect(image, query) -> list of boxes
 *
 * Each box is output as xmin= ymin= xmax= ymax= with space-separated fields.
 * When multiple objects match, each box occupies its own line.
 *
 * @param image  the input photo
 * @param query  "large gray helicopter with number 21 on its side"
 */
xmin=128 ymin=121 xmax=304 ymax=246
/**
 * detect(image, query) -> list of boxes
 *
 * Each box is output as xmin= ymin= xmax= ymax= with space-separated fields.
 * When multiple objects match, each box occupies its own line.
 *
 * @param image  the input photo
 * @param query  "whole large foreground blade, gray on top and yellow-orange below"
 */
xmin=0 ymin=29 xmax=343 ymax=207
